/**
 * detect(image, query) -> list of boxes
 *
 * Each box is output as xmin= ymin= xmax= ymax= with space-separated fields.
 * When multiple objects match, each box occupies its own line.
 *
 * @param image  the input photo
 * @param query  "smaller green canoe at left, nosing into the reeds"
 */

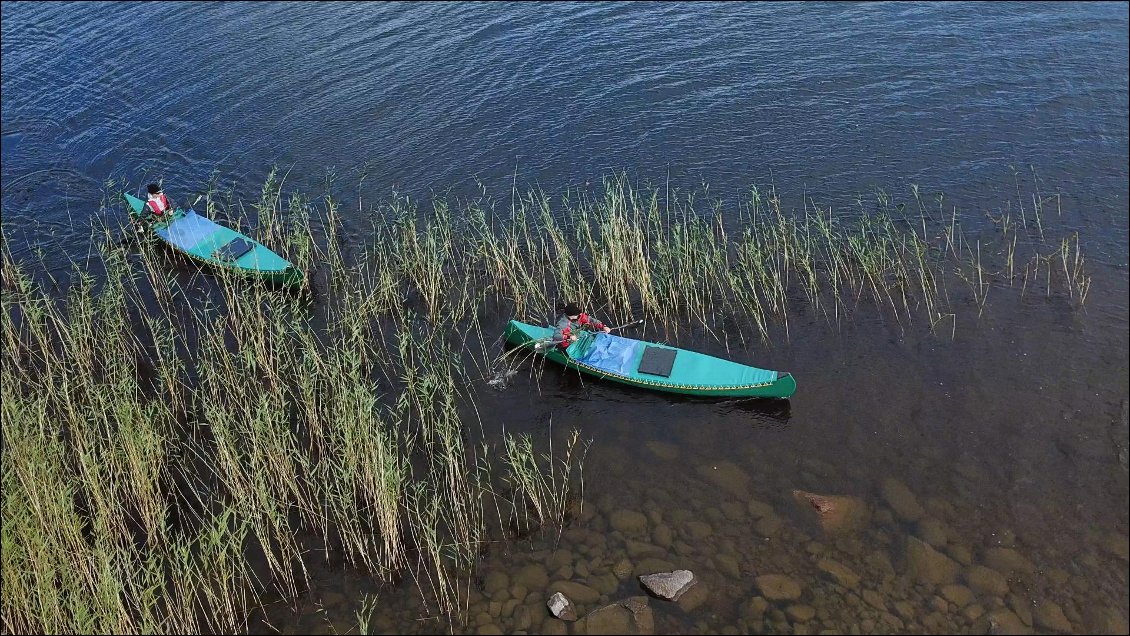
xmin=122 ymin=194 xmax=304 ymax=287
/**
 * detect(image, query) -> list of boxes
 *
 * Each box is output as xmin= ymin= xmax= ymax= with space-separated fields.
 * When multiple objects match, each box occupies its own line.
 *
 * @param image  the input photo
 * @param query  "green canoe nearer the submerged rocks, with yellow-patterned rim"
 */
xmin=506 ymin=320 xmax=797 ymax=398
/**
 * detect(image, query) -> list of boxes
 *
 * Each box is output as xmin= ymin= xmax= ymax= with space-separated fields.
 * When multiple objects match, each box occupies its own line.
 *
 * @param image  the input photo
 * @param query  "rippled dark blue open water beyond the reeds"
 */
xmin=2 ymin=2 xmax=1128 ymax=256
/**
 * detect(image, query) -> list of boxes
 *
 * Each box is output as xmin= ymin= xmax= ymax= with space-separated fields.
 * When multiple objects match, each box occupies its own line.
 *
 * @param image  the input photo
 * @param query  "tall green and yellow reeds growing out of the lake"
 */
xmin=0 ymin=172 xmax=1090 ymax=634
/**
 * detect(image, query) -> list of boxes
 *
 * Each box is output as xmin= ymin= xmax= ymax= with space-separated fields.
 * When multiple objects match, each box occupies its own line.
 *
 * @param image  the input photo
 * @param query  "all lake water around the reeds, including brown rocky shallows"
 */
xmin=0 ymin=2 xmax=1130 ymax=633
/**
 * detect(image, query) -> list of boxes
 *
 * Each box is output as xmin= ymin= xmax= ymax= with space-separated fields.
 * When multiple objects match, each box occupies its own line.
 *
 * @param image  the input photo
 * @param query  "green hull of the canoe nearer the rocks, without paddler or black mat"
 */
xmin=505 ymin=320 xmax=797 ymax=398
